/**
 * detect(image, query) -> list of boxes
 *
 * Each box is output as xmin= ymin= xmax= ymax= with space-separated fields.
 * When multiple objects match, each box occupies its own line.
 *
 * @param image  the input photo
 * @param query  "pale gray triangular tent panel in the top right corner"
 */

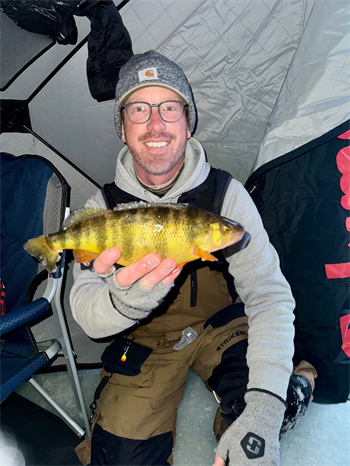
xmin=254 ymin=0 xmax=350 ymax=170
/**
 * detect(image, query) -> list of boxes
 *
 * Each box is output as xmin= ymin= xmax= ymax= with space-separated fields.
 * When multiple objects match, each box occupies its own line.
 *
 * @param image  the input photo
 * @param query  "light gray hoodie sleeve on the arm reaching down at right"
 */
xmin=222 ymin=180 xmax=295 ymax=399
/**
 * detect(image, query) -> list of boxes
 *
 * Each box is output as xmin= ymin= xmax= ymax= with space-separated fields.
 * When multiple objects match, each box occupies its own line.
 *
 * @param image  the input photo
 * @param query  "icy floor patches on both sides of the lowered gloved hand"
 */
xmin=174 ymin=373 xmax=350 ymax=466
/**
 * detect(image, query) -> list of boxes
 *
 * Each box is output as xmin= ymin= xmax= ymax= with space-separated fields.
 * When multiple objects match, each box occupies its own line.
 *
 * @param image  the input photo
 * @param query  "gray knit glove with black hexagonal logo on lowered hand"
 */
xmin=215 ymin=390 xmax=286 ymax=466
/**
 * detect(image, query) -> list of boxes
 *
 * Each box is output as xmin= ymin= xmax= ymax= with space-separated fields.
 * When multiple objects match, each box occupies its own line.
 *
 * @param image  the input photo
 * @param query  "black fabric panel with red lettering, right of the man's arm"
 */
xmin=246 ymin=124 xmax=350 ymax=403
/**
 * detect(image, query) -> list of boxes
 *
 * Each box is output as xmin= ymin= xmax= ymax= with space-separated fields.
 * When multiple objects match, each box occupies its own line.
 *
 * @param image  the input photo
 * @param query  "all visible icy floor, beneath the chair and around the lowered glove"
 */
xmin=15 ymin=370 xmax=350 ymax=466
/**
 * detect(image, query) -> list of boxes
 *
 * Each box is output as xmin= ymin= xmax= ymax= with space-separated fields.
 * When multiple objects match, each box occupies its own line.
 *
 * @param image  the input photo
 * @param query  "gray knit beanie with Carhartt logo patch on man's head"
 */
xmin=114 ymin=50 xmax=197 ymax=138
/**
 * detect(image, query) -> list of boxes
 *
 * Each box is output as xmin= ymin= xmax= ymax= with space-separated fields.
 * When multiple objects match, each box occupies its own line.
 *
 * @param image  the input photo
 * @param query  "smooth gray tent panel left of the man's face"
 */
xmin=29 ymin=48 xmax=123 ymax=184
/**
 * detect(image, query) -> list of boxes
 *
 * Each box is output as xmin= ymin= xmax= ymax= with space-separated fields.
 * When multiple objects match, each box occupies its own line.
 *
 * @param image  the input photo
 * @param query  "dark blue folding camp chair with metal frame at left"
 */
xmin=0 ymin=153 xmax=90 ymax=437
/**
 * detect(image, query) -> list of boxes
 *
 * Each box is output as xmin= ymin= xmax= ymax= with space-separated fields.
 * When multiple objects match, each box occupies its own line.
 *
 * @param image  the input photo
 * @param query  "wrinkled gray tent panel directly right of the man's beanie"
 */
xmin=159 ymin=0 xmax=305 ymax=182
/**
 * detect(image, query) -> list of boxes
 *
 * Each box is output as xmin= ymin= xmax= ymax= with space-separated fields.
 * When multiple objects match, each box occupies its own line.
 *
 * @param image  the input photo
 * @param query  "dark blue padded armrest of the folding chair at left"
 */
xmin=0 ymin=298 xmax=51 ymax=335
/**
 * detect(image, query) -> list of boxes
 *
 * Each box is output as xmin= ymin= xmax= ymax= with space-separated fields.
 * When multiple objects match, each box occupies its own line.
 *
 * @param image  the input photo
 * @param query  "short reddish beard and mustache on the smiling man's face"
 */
xmin=129 ymin=132 xmax=187 ymax=175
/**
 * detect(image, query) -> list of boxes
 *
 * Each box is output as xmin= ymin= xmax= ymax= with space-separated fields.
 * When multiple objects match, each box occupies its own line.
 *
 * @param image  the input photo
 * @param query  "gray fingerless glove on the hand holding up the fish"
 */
xmin=99 ymin=267 xmax=173 ymax=320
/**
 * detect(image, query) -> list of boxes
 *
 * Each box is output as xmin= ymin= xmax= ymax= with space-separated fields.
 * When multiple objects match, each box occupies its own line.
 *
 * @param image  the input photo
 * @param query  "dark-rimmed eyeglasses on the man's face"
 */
xmin=121 ymin=100 xmax=188 ymax=124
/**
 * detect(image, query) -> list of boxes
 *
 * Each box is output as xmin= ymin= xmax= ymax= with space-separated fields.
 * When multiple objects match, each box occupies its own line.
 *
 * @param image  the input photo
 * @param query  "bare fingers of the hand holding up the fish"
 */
xmin=94 ymin=247 xmax=181 ymax=291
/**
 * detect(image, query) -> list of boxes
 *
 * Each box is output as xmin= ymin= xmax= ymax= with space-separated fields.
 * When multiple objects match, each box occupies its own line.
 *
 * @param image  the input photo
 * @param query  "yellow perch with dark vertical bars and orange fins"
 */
xmin=24 ymin=201 xmax=244 ymax=272
